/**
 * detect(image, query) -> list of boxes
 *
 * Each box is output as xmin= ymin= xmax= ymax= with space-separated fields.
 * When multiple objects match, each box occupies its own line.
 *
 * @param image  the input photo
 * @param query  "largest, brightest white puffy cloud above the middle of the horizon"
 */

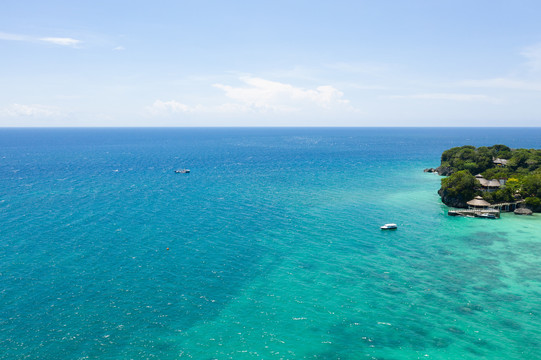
xmin=213 ymin=77 xmax=348 ymax=111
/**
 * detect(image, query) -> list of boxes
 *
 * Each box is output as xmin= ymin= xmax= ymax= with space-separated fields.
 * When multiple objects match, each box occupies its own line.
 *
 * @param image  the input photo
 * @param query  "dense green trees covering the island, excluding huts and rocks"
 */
xmin=438 ymin=145 xmax=541 ymax=211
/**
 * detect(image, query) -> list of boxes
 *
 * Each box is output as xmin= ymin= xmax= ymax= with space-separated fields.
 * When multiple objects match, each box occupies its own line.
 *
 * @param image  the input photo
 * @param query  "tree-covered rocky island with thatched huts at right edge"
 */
xmin=425 ymin=145 xmax=541 ymax=214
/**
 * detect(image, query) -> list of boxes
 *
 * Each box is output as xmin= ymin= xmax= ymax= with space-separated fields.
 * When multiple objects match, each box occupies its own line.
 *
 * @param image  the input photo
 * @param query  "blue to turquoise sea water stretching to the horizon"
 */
xmin=0 ymin=128 xmax=541 ymax=359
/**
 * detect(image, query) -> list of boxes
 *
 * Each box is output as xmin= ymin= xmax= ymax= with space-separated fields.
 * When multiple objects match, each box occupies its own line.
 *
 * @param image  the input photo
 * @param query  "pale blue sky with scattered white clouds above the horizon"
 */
xmin=0 ymin=0 xmax=541 ymax=127
